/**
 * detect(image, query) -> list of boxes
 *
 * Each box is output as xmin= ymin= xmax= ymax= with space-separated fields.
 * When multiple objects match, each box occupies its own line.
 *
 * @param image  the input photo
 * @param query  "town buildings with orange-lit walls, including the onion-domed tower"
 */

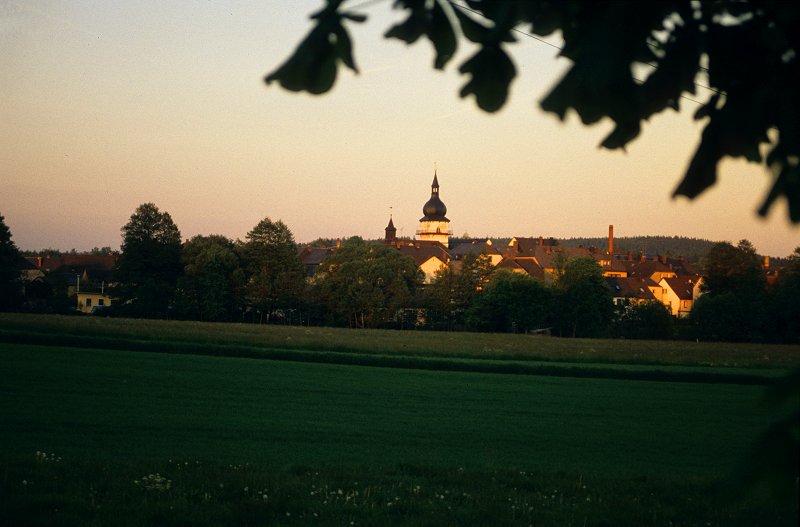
xmin=24 ymin=173 xmax=772 ymax=317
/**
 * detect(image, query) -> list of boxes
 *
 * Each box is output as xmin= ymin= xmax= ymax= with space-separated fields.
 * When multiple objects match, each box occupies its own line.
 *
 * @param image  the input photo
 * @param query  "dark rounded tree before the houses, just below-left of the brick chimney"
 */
xmin=555 ymin=256 xmax=614 ymax=337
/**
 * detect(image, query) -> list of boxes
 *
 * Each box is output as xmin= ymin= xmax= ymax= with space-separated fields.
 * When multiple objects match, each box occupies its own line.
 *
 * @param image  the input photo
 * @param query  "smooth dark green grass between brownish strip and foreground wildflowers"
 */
xmin=0 ymin=344 xmax=770 ymax=478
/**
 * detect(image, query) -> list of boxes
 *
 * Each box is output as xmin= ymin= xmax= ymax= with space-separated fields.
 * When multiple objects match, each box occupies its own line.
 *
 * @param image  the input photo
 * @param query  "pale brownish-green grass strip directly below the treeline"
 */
xmin=0 ymin=313 xmax=800 ymax=369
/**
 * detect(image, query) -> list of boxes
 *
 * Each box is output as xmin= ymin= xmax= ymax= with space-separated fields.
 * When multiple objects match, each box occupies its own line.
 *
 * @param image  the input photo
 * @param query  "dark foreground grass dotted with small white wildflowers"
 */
xmin=0 ymin=454 xmax=797 ymax=527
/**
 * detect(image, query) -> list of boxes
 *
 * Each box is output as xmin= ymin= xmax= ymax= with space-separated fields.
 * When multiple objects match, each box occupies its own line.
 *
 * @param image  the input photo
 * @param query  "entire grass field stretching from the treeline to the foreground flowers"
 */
xmin=0 ymin=315 xmax=798 ymax=525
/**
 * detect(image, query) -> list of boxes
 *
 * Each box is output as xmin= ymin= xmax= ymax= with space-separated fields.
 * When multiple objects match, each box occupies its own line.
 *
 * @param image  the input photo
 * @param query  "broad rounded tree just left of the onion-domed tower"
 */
xmin=314 ymin=239 xmax=423 ymax=328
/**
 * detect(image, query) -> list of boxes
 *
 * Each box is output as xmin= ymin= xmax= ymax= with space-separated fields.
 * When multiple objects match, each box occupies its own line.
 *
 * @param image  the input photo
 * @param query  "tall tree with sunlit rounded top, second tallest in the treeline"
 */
xmin=242 ymin=217 xmax=305 ymax=321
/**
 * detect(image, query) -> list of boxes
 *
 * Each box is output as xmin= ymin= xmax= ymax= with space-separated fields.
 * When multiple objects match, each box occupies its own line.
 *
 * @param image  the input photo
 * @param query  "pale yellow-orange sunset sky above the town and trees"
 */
xmin=0 ymin=0 xmax=800 ymax=256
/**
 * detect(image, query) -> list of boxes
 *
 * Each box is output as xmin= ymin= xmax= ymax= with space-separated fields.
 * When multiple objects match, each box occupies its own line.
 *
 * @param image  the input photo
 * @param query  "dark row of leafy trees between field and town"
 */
xmin=0 ymin=203 xmax=800 ymax=342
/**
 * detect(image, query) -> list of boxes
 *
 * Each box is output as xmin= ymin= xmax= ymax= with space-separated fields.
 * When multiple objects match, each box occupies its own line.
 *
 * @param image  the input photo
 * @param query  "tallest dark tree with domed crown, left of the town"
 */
xmin=117 ymin=203 xmax=182 ymax=317
